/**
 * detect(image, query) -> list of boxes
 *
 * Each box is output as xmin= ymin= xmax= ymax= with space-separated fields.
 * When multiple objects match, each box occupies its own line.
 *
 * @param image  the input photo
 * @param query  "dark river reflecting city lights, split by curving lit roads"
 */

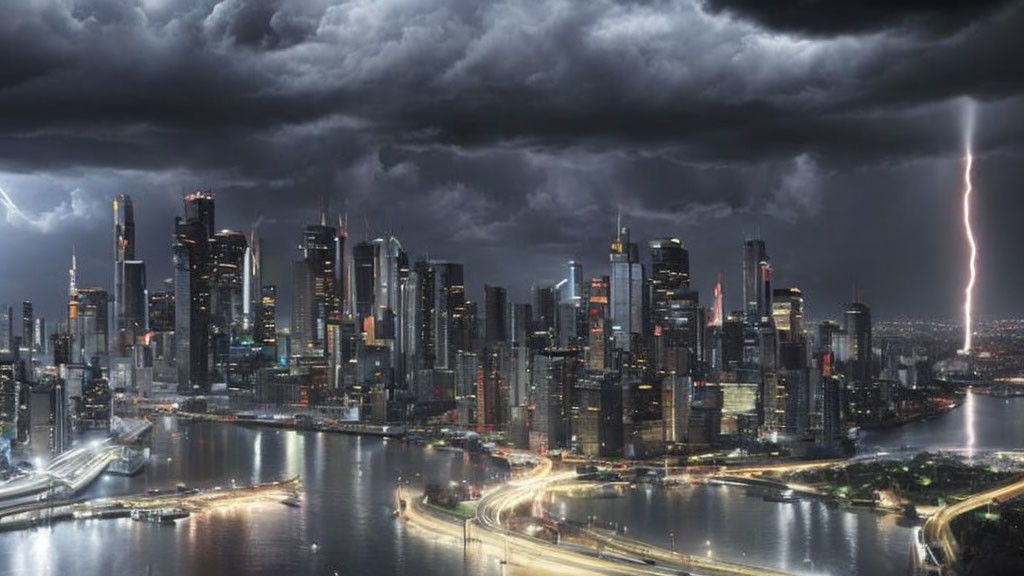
xmin=0 ymin=396 xmax=1007 ymax=576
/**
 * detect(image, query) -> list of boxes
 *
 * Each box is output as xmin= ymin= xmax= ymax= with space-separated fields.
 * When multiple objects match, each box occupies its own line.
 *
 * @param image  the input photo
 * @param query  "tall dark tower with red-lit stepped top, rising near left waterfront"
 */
xmin=172 ymin=192 xmax=214 ymax=394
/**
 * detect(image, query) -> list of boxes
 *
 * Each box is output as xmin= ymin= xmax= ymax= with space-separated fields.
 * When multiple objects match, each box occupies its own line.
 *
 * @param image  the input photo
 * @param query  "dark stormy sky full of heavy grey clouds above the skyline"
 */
xmin=0 ymin=0 xmax=1024 ymax=327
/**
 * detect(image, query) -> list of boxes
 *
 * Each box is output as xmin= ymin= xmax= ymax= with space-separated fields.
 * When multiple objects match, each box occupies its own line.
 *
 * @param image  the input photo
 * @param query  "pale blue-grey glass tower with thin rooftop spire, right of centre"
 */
xmin=608 ymin=227 xmax=645 ymax=352
